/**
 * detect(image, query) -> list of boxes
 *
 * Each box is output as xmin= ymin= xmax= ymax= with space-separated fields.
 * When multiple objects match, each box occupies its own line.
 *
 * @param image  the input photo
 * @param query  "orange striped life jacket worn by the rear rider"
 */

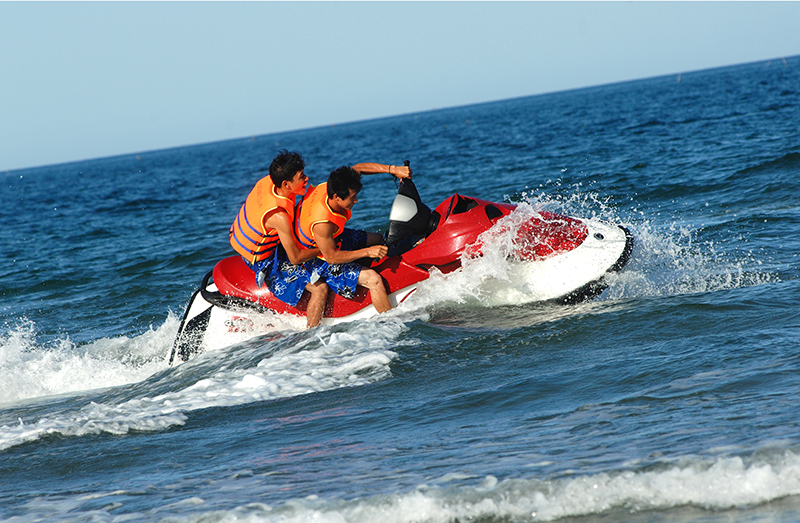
xmin=229 ymin=176 xmax=294 ymax=264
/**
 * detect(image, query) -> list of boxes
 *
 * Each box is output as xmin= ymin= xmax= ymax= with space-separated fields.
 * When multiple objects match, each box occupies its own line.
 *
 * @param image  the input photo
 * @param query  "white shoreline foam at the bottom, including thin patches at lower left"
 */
xmin=14 ymin=450 xmax=800 ymax=523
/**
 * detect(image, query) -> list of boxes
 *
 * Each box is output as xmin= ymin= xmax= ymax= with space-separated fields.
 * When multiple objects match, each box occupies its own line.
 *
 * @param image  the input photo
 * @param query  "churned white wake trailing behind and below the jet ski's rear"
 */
xmin=0 ymin=318 xmax=405 ymax=450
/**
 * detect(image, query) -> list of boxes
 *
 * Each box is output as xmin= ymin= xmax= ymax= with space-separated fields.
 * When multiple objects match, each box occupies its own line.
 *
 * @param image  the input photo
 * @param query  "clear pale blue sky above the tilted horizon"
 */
xmin=0 ymin=2 xmax=800 ymax=171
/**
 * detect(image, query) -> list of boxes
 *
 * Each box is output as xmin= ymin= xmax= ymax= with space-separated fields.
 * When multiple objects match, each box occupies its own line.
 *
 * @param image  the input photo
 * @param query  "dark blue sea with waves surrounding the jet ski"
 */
xmin=0 ymin=56 xmax=800 ymax=523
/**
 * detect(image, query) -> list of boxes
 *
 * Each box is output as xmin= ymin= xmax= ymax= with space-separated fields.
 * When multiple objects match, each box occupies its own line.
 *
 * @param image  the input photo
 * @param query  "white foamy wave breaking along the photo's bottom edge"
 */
xmin=187 ymin=451 xmax=800 ymax=523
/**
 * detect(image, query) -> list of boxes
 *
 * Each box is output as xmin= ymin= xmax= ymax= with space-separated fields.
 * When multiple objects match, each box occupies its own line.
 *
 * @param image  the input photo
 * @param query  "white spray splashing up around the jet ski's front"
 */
xmin=406 ymin=192 xmax=778 ymax=316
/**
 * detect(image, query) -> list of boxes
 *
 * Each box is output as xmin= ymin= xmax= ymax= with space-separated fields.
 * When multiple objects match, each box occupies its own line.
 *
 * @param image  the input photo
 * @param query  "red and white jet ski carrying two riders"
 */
xmin=169 ymin=179 xmax=633 ymax=365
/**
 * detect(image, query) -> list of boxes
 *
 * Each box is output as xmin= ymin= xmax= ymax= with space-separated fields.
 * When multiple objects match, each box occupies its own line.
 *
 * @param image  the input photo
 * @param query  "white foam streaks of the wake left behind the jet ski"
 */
xmin=0 ymin=321 xmax=404 ymax=449
